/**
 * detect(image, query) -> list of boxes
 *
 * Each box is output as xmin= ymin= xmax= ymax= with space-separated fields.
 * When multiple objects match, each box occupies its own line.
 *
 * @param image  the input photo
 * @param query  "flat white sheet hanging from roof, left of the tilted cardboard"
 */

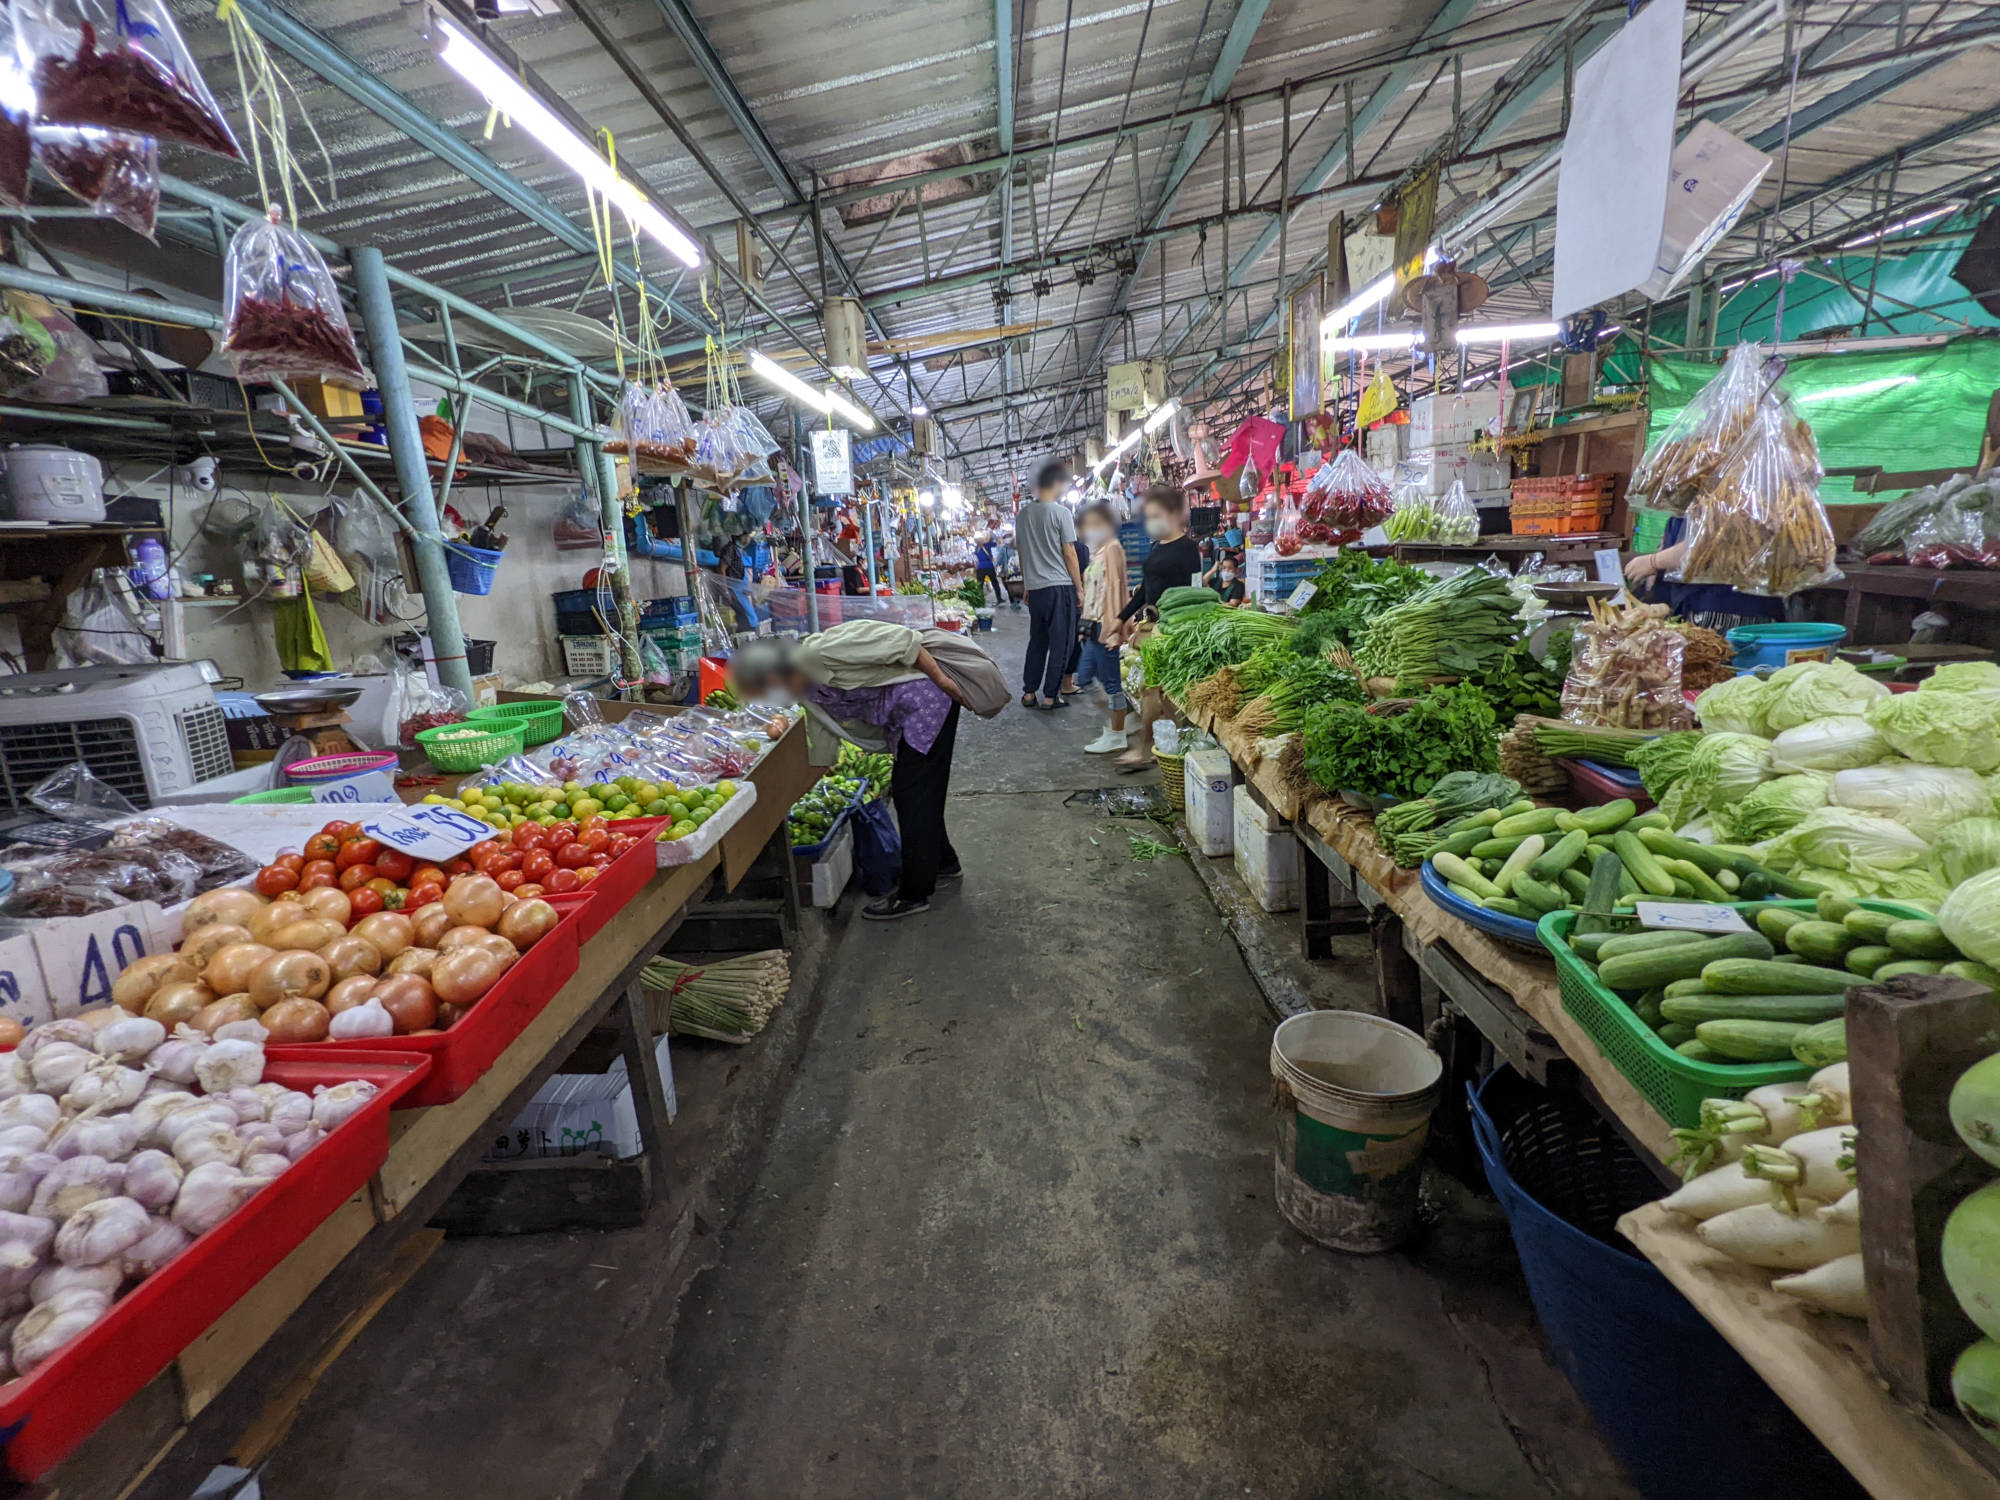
xmin=1550 ymin=0 xmax=1686 ymax=318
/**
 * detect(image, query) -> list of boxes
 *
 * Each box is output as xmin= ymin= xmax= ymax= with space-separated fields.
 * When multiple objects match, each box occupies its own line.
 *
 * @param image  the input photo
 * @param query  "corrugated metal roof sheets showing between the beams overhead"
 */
xmin=148 ymin=0 xmax=2000 ymax=494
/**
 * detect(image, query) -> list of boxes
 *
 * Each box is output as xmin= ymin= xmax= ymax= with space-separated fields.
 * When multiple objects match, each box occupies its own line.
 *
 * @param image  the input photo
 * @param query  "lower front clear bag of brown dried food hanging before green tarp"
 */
xmin=1680 ymin=396 xmax=1840 ymax=598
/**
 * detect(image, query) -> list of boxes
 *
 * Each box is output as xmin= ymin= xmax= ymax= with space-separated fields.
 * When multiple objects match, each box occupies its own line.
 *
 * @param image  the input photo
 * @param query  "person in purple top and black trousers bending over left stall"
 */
xmin=730 ymin=620 xmax=966 ymax=922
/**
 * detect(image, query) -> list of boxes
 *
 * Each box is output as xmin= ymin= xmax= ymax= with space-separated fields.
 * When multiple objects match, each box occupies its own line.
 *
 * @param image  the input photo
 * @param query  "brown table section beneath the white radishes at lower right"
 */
xmin=1618 ymin=1204 xmax=2000 ymax=1500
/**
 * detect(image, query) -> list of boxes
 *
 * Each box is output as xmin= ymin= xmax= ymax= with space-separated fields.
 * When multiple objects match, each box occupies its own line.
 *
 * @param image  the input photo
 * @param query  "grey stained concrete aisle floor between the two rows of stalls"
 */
xmin=264 ymin=614 xmax=1628 ymax=1500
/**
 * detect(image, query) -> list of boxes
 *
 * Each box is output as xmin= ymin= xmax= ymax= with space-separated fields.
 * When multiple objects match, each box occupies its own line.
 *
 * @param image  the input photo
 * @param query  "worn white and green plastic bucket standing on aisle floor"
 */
xmin=1270 ymin=1010 xmax=1444 ymax=1254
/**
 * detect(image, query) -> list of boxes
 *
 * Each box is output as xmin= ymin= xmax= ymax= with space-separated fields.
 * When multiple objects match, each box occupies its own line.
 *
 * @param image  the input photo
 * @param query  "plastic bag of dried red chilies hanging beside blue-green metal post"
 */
xmin=222 ymin=208 xmax=368 ymax=386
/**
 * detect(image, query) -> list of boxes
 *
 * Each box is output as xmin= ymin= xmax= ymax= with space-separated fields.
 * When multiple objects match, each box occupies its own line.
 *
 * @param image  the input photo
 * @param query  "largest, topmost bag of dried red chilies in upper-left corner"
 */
xmin=12 ymin=0 xmax=242 ymax=160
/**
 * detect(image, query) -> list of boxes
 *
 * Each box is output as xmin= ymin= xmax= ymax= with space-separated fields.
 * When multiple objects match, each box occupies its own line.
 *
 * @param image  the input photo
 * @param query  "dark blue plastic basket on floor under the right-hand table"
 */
xmin=1466 ymin=1068 xmax=1862 ymax=1500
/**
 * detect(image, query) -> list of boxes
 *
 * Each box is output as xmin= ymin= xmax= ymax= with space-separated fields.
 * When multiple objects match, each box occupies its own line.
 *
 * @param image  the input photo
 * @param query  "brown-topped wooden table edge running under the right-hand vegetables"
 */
xmin=1184 ymin=710 xmax=2000 ymax=1500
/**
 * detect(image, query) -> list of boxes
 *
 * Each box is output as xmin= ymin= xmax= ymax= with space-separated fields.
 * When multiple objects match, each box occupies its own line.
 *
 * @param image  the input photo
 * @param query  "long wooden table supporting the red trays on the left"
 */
xmin=35 ymin=726 xmax=818 ymax=1500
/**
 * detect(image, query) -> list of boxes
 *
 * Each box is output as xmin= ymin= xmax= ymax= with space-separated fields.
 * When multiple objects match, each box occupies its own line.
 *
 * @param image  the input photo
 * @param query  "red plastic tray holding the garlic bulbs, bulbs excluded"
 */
xmin=0 ymin=1048 xmax=430 ymax=1480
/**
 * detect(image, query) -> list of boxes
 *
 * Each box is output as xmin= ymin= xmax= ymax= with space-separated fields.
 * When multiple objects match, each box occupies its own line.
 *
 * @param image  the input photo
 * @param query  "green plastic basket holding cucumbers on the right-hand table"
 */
xmin=1536 ymin=900 xmax=1924 ymax=1126
